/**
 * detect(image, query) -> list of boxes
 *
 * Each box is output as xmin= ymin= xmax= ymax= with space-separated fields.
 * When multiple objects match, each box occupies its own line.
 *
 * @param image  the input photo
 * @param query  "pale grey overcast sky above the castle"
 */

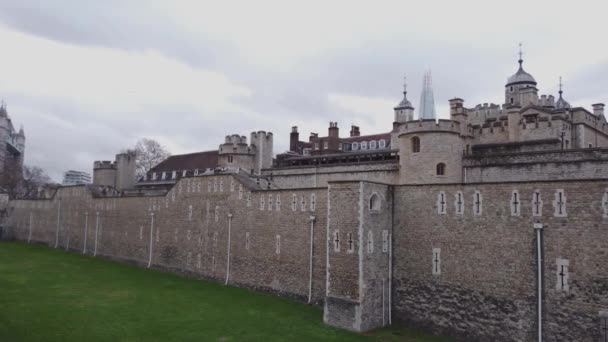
xmin=0 ymin=0 xmax=608 ymax=181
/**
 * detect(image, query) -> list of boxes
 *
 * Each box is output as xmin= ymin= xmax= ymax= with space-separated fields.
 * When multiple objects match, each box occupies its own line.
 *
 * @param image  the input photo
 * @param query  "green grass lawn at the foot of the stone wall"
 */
xmin=0 ymin=242 xmax=448 ymax=342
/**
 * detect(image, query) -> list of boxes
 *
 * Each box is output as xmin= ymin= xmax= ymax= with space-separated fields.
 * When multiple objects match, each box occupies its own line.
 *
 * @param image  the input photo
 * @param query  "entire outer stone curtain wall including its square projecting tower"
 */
xmin=7 ymin=175 xmax=608 ymax=342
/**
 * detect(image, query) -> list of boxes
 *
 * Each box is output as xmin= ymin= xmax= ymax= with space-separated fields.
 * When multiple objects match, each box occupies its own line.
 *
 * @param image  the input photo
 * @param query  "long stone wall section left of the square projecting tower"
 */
xmin=9 ymin=176 xmax=327 ymax=302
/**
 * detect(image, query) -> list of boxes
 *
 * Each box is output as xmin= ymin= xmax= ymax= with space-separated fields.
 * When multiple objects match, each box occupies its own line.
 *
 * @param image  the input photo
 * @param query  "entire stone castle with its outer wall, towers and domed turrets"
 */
xmin=8 ymin=54 xmax=608 ymax=342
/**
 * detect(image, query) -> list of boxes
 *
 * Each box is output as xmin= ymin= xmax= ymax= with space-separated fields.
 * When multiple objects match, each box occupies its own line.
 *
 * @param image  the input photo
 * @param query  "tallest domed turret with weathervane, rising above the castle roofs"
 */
xmin=505 ymin=44 xmax=538 ymax=107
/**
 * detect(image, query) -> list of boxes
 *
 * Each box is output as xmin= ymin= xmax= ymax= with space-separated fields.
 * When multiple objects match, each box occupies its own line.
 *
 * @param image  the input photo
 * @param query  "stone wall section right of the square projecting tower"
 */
xmin=393 ymin=181 xmax=608 ymax=342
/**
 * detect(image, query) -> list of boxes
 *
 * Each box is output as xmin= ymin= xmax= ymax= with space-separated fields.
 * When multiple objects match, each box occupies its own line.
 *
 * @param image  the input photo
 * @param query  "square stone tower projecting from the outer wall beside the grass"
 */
xmin=324 ymin=182 xmax=393 ymax=331
